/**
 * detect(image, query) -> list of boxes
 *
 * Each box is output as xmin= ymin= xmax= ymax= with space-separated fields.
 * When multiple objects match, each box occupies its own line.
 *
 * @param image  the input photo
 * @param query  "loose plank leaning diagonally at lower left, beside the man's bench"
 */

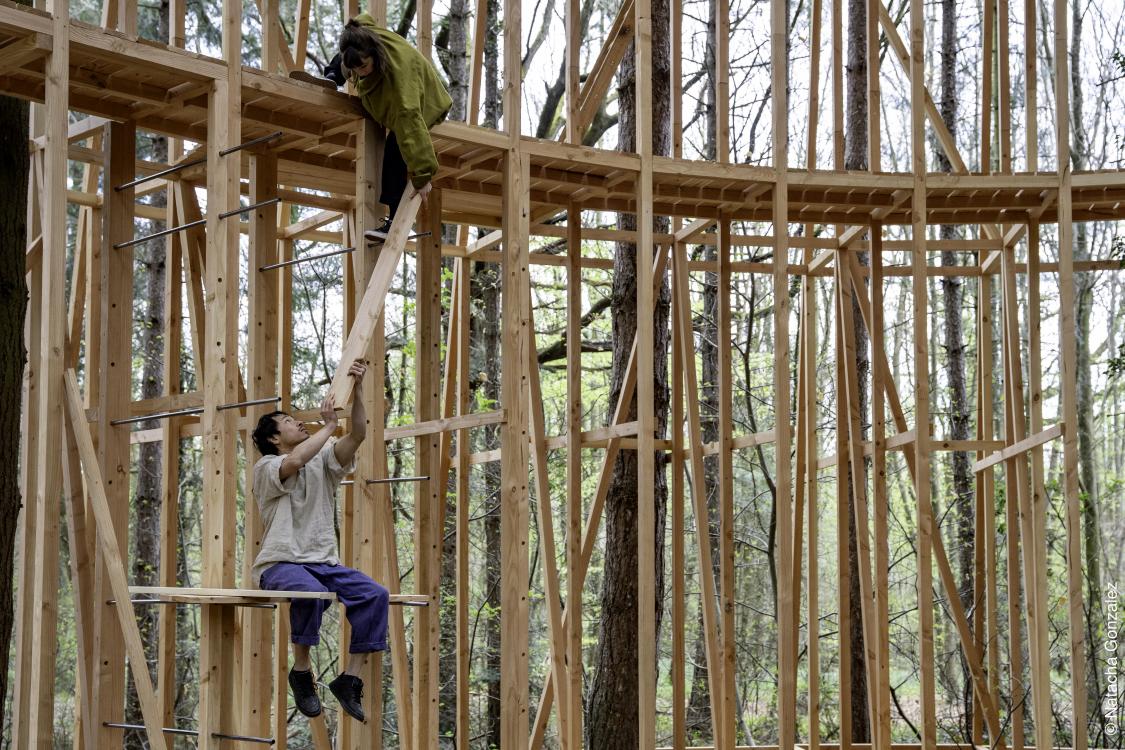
xmin=63 ymin=370 xmax=167 ymax=749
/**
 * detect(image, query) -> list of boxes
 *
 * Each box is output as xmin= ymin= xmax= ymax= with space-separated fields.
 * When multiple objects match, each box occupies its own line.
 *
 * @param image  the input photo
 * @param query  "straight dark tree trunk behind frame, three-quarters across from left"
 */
xmin=840 ymin=0 xmax=871 ymax=742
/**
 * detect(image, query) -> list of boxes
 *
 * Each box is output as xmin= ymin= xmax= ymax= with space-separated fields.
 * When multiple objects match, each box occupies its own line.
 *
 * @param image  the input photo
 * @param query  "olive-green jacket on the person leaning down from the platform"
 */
xmin=356 ymin=13 xmax=453 ymax=188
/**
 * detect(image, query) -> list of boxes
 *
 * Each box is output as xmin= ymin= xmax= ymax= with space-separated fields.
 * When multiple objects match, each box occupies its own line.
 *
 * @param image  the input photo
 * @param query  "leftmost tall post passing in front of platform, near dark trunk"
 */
xmin=23 ymin=0 xmax=70 ymax=747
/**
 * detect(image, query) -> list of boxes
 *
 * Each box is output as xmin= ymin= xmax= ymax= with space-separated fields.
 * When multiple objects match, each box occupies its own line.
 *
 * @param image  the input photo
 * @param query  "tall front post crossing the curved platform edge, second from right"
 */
xmin=910 ymin=0 xmax=952 ymax=750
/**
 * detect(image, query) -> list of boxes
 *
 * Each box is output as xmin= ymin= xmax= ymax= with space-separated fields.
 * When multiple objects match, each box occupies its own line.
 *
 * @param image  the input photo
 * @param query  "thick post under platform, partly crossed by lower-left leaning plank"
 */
xmin=92 ymin=115 xmax=136 ymax=747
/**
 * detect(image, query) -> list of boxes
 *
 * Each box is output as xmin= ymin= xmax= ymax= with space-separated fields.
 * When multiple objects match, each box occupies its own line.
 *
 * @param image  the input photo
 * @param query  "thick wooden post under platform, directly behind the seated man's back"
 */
xmin=239 ymin=150 xmax=278 ymax=737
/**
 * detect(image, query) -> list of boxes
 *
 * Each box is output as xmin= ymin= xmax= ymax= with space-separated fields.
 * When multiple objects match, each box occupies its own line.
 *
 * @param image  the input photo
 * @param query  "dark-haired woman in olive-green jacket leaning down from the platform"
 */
xmin=340 ymin=13 xmax=453 ymax=240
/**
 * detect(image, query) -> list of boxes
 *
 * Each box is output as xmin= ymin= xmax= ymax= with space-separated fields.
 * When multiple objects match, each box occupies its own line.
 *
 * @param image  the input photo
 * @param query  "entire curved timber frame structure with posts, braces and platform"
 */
xmin=0 ymin=0 xmax=1125 ymax=750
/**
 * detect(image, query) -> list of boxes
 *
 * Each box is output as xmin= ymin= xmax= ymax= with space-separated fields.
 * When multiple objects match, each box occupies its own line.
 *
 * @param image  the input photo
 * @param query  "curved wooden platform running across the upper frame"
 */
xmin=0 ymin=0 xmax=1125 ymax=226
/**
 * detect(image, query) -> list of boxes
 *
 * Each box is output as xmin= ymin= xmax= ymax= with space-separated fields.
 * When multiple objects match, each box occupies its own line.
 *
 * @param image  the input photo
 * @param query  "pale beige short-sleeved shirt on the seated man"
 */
xmin=251 ymin=437 xmax=356 ymax=586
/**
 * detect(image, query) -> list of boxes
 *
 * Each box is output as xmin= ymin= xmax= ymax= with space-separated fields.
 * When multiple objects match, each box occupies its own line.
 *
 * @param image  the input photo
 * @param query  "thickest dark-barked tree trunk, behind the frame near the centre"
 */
xmin=586 ymin=0 xmax=672 ymax=750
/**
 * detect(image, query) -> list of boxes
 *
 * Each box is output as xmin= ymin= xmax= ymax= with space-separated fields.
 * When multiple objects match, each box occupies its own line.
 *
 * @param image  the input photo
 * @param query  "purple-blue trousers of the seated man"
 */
xmin=261 ymin=562 xmax=389 ymax=653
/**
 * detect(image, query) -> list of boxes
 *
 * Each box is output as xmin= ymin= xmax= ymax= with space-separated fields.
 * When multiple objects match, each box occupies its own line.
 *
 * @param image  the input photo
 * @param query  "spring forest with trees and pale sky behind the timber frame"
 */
xmin=2 ymin=0 xmax=1125 ymax=748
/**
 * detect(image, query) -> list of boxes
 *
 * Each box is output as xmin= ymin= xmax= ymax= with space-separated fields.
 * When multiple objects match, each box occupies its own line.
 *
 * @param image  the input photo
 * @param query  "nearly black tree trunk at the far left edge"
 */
xmin=0 ymin=54 xmax=28 ymax=726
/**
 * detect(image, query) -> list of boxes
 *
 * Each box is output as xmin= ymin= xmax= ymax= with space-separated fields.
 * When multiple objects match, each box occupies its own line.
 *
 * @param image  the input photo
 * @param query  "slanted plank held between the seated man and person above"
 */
xmin=329 ymin=184 xmax=422 ymax=408
